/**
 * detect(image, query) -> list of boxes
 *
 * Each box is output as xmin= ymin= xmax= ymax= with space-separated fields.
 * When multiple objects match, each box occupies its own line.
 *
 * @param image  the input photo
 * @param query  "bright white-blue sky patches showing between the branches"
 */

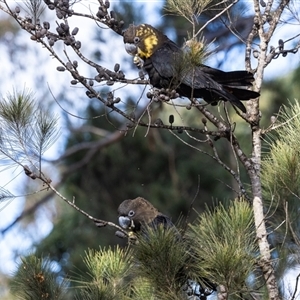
xmin=0 ymin=0 xmax=299 ymax=296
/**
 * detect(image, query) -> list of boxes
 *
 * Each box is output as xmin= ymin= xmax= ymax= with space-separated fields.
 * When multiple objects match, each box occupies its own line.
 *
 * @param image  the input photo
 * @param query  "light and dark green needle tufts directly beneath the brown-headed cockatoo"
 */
xmin=73 ymin=228 xmax=188 ymax=300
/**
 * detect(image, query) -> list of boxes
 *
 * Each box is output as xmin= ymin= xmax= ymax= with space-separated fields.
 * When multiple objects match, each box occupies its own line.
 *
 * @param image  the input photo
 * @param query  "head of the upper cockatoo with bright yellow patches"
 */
xmin=123 ymin=24 xmax=168 ymax=60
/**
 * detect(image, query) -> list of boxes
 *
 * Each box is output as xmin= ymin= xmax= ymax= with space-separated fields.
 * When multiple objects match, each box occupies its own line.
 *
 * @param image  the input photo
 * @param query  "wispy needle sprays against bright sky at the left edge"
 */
xmin=0 ymin=91 xmax=57 ymax=165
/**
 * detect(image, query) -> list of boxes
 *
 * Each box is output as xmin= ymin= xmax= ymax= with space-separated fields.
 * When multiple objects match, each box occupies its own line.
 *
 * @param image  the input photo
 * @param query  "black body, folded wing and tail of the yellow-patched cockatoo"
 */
xmin=144 ymin=39 xmax=253 ymax=112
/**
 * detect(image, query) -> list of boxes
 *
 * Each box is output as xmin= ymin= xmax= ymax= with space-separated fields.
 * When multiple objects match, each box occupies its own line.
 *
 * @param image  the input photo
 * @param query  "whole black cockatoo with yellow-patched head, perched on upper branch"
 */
xmin=123 ymin=24 xmax=259 ymax=113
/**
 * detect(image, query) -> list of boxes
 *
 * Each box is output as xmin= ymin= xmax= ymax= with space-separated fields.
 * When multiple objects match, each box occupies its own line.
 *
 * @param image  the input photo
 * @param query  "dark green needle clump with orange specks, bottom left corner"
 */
xmin=11 ymin=255 xmax=67 ymax=300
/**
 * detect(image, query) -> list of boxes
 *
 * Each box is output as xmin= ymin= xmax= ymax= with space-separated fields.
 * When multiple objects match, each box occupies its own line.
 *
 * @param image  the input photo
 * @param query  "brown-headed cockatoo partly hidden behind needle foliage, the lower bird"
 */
xmin=118 ymin=197 xmax=216 ymax=300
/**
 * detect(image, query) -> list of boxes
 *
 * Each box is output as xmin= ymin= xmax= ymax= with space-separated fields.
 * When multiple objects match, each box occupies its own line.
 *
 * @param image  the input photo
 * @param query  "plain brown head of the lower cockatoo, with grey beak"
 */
xmin=118 ymin=197 xmax=159 ymax=232
